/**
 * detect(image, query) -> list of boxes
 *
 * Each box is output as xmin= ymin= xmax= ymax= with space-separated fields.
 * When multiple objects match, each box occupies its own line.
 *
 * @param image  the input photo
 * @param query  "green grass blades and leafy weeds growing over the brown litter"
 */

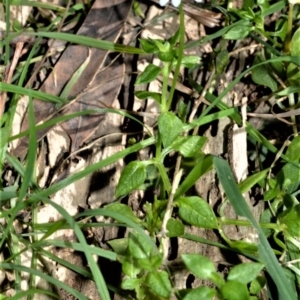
xmin=0 ymin=1 xmax=300 ymax=300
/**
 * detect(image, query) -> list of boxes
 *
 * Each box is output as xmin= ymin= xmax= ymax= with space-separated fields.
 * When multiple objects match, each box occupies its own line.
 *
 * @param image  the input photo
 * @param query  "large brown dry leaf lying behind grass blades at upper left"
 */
xmin=13 ymin=0 xmax=132 ymax=158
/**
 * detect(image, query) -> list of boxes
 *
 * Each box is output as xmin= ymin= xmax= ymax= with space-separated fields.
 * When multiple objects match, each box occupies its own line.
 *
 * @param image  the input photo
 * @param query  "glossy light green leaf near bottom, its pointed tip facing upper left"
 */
xmin=181 ymin=254 xmax=216 ymax=280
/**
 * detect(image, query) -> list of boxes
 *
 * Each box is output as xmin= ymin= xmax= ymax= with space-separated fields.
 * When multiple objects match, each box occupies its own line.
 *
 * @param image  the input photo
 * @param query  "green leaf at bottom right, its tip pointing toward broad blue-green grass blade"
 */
xmin=227 ymin=263 xmax=264 ymax=284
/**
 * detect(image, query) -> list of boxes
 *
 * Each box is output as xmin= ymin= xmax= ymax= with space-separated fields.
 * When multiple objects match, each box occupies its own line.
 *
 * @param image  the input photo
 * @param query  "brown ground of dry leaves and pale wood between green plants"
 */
xmin=0 ymin=0 xmax=296 ymax=299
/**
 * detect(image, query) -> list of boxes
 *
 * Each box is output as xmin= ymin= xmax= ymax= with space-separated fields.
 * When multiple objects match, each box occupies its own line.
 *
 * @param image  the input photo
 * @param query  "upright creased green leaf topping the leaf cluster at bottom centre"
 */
xmin=128 ymin=232 xmax=152 ymax=259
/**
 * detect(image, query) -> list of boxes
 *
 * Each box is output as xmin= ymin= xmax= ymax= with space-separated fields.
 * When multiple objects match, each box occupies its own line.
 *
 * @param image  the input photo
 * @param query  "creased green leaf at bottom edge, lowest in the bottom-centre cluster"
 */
xmin=146 ymin=271 xmax=172 ymax=299
